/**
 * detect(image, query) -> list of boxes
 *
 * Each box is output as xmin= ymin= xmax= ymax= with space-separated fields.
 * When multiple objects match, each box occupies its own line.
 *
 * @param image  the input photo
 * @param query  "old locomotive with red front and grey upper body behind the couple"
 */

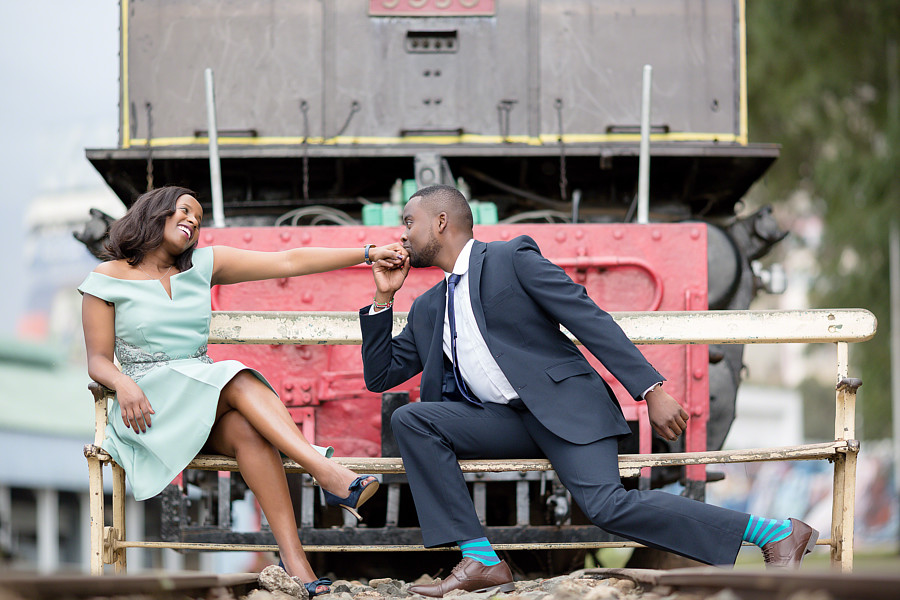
xmin=85 ymin=0 xmax=784 ymax=572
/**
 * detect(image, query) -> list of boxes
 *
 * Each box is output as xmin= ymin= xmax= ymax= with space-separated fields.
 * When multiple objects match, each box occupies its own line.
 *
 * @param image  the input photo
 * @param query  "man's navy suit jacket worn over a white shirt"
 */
xmin=360 ymin=236 xmax=665 ymax=444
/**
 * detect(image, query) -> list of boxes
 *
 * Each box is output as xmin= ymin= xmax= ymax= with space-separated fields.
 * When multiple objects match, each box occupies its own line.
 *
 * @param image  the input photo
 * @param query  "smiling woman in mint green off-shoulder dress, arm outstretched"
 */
xmin=78 ymin=187 xmax=404 ymax=595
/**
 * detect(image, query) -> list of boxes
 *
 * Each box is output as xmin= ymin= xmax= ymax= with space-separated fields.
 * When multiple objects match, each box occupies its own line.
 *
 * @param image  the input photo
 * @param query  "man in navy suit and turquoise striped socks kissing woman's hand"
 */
xmin=360 ymin=186 xmax=818 ymax=597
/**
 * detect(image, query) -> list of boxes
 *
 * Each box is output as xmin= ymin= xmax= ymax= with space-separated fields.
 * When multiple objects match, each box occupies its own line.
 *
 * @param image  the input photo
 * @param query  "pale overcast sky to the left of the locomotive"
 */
xmin=0 ymin=0 xmax=119 ymax=336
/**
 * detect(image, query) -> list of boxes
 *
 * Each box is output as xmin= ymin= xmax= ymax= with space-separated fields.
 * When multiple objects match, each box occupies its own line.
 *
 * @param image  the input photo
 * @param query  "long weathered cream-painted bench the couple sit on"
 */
xmin=84 ymin=309 xmax=877 ymax=574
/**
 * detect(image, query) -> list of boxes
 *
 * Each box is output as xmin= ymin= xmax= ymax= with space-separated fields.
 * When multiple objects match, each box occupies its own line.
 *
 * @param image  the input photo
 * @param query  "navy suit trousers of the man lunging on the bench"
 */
xmin=391 ymin=401 xmax=750 ymax=565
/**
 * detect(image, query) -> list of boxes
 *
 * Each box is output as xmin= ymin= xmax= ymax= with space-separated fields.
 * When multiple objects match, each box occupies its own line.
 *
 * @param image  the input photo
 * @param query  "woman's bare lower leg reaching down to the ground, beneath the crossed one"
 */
xmin=206 ymin=402 xmax=324 ymax=591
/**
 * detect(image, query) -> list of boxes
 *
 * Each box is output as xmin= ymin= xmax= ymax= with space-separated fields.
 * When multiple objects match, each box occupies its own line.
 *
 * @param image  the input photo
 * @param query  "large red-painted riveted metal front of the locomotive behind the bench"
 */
xmin=203 ymin=223 xmax=709 ymax=480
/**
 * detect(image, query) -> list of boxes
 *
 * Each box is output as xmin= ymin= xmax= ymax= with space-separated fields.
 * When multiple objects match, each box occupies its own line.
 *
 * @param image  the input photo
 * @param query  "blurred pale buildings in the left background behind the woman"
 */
xmin=0 ymin=188 xmax=261 ymax=573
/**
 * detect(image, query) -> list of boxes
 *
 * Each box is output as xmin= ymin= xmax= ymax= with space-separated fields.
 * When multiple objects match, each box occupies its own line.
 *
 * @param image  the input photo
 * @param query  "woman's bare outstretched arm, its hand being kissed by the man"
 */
xmin=212 ymin=243 xmax=405 ymax=284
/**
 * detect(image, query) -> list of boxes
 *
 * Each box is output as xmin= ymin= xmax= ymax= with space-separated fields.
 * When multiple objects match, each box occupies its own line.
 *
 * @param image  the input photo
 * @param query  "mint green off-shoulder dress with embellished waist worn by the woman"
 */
xmin=78 ymin=248 xmax=331 ymax=500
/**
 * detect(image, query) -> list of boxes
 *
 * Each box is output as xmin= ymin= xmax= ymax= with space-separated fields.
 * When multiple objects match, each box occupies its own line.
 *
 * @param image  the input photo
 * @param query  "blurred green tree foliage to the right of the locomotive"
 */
xmin=746 ymin=0 xmax=900 ymax=439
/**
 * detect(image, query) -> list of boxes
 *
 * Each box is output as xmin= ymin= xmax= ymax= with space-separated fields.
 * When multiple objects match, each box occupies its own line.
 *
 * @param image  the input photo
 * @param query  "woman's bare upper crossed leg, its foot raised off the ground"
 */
xmin=216 ymin=371 xmax=370 ymax=506
